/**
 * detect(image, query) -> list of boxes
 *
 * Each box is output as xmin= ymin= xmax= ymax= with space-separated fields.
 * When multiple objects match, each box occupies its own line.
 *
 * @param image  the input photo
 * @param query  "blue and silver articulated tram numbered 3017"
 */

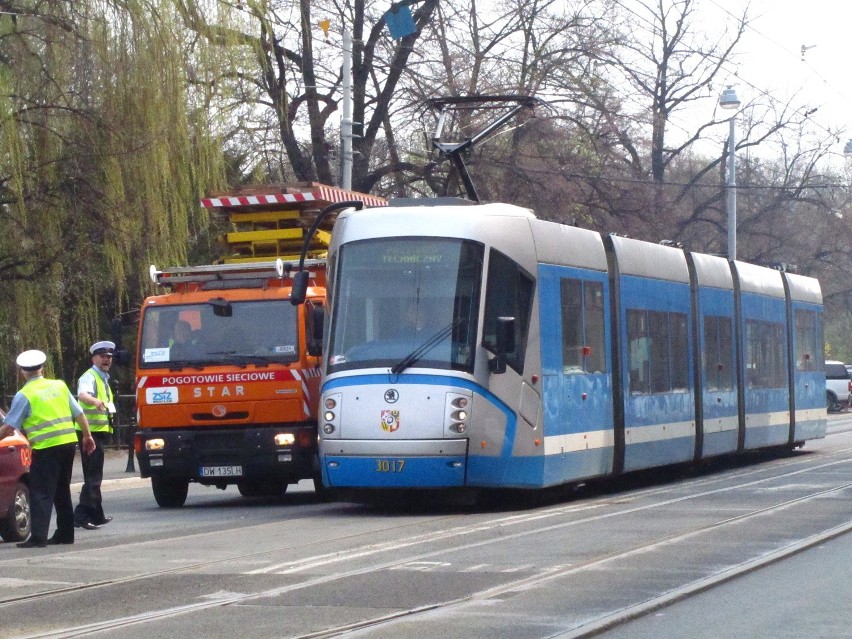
xmin=320 ymin=204 xmax=826 ymax=489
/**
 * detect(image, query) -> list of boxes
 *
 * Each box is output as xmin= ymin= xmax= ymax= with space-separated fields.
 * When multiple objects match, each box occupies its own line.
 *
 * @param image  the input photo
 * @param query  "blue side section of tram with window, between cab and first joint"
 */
xmin=539 ymin=266 xmax=614 ymax=484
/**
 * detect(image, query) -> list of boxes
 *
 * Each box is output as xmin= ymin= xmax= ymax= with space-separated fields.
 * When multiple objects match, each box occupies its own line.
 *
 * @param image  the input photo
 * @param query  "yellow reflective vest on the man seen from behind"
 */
xmin=21 ymin=377 xmax=77 ymax=450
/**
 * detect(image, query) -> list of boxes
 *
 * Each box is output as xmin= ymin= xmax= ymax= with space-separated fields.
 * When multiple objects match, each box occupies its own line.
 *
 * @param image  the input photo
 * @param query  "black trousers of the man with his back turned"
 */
xmin=30 ymin=444 xmax=77 ymax=541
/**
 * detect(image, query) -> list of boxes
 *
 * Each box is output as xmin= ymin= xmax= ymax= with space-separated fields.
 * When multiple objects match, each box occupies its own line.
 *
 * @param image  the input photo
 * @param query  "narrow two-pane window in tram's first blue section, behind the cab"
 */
xmin=561 ymin=278 xmax=606 ymax=373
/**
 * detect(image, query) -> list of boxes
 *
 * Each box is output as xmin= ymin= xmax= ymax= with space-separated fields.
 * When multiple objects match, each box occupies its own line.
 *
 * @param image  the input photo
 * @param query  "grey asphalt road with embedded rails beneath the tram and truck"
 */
xmin=0 ymin=415 xmax=852 ymax=639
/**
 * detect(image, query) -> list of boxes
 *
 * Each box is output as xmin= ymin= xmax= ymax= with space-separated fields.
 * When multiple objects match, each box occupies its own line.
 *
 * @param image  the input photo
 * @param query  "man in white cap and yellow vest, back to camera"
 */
xmin=0 ymin=350 xmax=95 ymax=548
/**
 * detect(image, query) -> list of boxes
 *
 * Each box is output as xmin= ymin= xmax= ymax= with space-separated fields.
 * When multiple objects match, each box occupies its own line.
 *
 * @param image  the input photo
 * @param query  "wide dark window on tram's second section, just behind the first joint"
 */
xmin=627 ymin=310 xmax=689 ymax=394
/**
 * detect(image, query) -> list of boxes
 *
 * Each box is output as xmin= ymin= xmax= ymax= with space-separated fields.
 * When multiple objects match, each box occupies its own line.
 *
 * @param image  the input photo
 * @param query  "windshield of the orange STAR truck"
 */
xmin=139 ymin=300 xmax=299 ymax=368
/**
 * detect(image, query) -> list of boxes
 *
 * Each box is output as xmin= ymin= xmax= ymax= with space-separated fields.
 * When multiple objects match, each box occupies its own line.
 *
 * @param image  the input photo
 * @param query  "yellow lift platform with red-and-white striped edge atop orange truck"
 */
xmin=201 ymin=182 xmax=387 ymax=264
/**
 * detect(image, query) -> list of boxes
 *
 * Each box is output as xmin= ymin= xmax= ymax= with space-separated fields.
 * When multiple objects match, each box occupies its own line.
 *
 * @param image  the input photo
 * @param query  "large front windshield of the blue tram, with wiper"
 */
xmin=328 ymin=238 xmax=484 ymax=373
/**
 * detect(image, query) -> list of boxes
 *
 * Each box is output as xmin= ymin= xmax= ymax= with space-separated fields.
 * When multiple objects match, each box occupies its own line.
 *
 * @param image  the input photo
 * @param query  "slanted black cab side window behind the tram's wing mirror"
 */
xmin=482 ymin=249 xmax=534 ymax=373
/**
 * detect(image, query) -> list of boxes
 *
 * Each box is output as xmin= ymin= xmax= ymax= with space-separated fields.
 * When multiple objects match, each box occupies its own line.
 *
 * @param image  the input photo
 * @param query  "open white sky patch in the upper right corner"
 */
xmin=700 ymin=0 xmax=852 ymax=153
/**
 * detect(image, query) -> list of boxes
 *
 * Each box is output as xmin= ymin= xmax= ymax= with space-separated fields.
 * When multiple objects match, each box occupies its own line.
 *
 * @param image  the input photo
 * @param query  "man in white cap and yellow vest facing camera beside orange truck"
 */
xmin=74 ymin=341 xmax=115 ymax=530
